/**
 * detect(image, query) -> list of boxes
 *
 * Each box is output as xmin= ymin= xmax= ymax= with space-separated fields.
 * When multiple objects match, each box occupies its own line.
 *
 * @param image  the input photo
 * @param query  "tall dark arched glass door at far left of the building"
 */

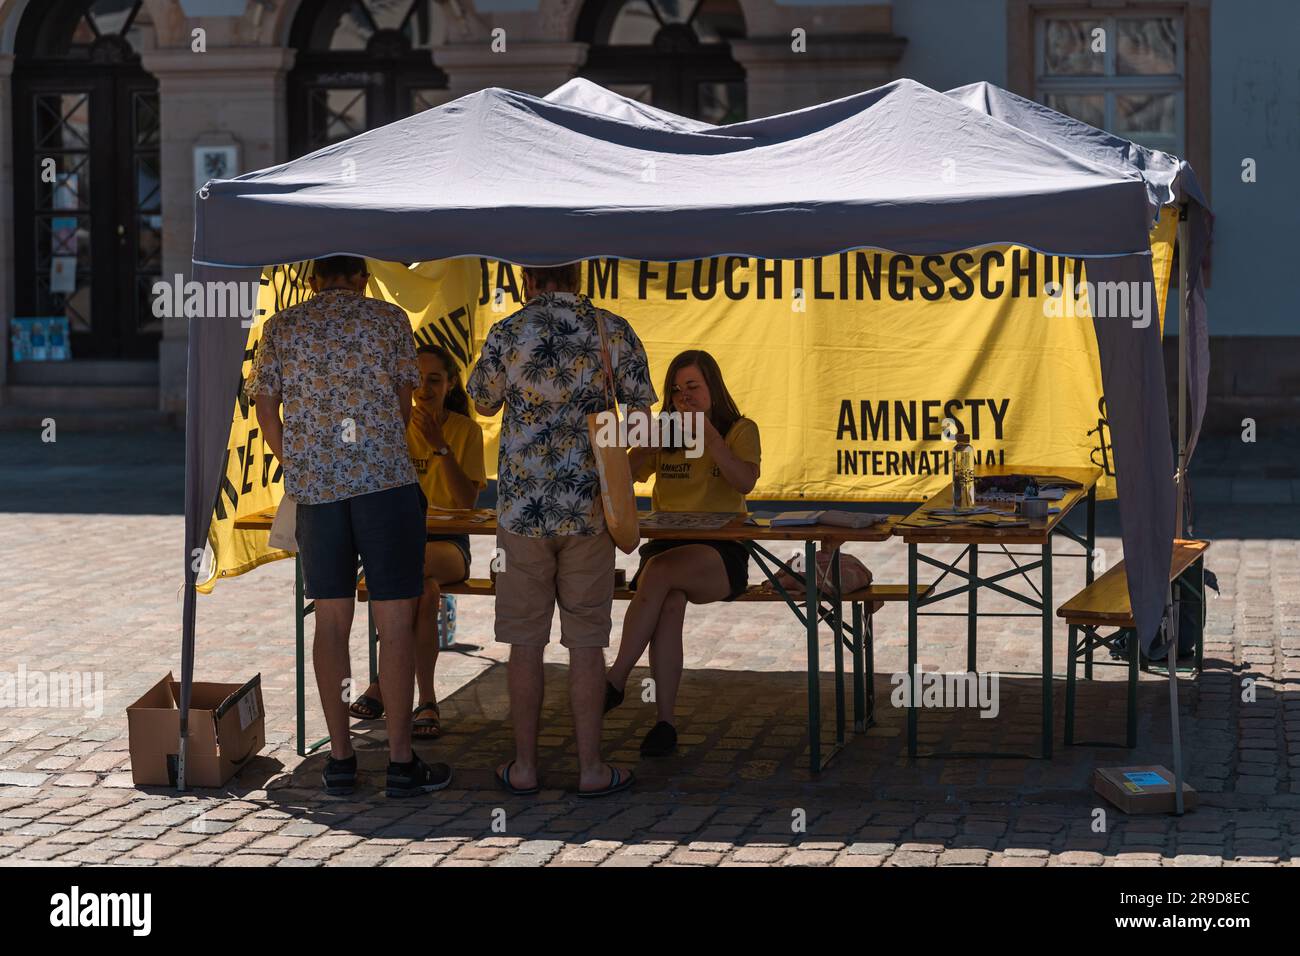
xmin=13 ymin=0 xmax=163 ymax=359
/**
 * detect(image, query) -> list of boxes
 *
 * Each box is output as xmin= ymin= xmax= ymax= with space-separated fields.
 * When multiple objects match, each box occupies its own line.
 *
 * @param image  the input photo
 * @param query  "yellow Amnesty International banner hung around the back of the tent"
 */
xmin=199 ymin=217 xmax=1177 ymax=592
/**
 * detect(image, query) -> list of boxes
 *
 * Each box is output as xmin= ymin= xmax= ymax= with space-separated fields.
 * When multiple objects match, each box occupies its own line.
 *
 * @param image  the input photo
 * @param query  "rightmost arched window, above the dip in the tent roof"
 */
xmin=577 ymin=0 xmax=746 ymax=124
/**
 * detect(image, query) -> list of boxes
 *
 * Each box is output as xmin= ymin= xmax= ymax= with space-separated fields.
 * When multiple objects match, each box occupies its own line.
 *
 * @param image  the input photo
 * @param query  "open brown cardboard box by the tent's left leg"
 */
xmin=126 ymin=671 xmax=267 ymax=787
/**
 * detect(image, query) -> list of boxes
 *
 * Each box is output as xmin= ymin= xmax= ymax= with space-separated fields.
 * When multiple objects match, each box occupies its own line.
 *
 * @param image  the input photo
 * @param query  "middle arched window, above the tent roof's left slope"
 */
xmin=289 ymin=0 xmax=447 ymax=156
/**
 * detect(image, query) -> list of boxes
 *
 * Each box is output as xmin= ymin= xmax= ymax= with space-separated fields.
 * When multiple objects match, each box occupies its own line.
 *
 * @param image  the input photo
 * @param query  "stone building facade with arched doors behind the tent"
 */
xmin=0 ymin=0 xmax=1300 ymax=424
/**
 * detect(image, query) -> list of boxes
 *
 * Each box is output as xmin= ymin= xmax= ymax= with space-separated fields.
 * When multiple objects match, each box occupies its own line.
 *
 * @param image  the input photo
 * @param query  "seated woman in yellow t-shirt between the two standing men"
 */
xmin=351 ymin=345 xmax=488 ymax=740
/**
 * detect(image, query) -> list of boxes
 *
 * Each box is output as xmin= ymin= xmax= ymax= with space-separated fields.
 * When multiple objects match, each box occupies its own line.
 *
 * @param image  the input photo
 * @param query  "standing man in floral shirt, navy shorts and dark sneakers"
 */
xmin=244 ymin=256 xmax=451 ymax=796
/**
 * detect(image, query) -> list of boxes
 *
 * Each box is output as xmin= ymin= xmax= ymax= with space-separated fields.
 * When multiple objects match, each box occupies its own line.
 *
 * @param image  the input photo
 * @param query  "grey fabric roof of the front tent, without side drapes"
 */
xmin=194 ymin=79 xmax=1151 ymax=267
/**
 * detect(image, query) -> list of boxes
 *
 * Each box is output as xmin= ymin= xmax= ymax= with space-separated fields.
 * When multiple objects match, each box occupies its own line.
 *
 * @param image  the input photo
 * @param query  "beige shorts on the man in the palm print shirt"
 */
xmin=497 ymin=529 xmax=614 ymax=648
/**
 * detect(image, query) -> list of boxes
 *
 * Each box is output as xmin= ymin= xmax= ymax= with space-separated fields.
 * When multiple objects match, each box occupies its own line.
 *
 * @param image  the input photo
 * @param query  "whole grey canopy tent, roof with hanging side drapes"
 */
xmin=181 ymin=74 xmax=1174 ymax=786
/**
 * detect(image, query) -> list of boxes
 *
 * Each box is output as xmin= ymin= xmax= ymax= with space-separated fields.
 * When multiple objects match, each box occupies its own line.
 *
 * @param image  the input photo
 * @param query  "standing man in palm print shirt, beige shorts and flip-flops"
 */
xmin=467 ymin=264 xmax=657 ymax=795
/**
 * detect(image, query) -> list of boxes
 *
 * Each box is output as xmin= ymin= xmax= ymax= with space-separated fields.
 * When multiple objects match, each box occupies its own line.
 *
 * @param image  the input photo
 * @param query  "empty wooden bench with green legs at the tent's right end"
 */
xmin=1057 ymin=538 xmax=1210 ymax=749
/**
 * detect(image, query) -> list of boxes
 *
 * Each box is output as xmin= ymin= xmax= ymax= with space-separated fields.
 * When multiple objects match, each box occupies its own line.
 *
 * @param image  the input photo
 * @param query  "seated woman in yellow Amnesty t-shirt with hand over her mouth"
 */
xmin=605 ymin=350 xmax=761 ymax=757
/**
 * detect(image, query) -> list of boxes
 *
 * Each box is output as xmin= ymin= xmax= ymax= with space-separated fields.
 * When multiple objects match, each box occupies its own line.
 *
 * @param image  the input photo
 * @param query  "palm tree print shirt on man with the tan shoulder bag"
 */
xmin=465 ymin=293 xmax=657 ymax=537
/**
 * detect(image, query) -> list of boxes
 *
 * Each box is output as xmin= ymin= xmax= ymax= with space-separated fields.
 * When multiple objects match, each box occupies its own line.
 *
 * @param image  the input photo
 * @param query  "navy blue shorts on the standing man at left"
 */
xmin=296 ymin=484 xmax=426 ymax=601
